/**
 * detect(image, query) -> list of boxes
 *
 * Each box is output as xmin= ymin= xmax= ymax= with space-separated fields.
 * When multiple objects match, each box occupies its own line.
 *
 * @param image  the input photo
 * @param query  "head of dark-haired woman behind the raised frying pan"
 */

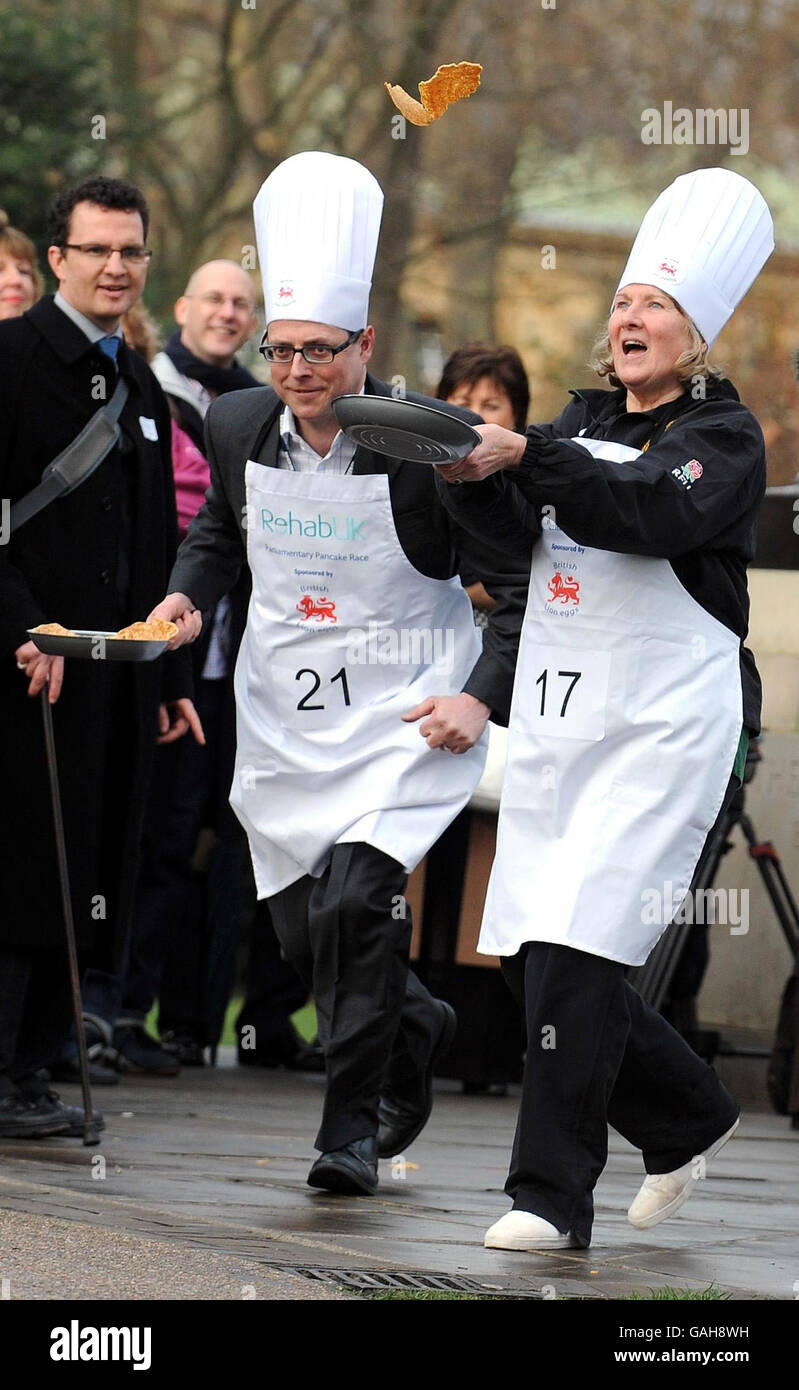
xmin=436 ymin=343 xmax=529 ymax=430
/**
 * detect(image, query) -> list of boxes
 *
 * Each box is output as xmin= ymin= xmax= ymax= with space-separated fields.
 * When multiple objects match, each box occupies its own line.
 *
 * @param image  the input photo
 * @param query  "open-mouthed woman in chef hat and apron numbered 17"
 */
xmin=440 ymin=170 xmax=774 ymax=1250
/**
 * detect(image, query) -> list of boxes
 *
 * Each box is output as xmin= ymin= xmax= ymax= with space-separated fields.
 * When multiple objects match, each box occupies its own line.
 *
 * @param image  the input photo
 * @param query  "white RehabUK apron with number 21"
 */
xmin=231 ymin=460 xmax=486 ymax=898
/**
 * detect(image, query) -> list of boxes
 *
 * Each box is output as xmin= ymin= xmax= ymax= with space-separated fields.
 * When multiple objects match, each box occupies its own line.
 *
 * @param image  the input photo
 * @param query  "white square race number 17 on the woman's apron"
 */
xmin=524 ymin=645 xmax=610 ymax=742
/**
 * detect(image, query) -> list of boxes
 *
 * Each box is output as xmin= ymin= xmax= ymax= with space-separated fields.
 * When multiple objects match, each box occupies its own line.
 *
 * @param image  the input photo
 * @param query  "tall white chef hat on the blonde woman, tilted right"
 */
xmin=616 ymin=170 xmax=774 ymax=346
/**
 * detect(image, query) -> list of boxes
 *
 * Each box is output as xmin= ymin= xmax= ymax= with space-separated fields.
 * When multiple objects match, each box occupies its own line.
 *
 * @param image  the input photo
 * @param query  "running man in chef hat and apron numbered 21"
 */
xmin=156 ymin=153 xmax=524 ymax=1194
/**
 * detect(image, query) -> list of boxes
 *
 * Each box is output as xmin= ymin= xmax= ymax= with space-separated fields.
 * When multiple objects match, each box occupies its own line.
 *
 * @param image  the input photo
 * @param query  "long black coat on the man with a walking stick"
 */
xmin=0 ymin=296 xmax=192 ymax=948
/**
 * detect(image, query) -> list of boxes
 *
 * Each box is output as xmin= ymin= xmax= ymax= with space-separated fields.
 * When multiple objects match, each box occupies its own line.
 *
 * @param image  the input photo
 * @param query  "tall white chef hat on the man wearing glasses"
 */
xmin=253 ymin=150 xmax=384 ymax=332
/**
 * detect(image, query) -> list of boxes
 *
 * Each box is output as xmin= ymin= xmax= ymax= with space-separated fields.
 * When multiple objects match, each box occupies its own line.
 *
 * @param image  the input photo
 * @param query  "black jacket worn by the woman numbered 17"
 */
xmin=439 ymin=379 xmax=766 ymax=733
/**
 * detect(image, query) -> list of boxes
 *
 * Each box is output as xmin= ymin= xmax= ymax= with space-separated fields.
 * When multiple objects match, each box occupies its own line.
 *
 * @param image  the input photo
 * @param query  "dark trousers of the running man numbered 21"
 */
xmin=268 ymin=844 xmax=440 ymax=1152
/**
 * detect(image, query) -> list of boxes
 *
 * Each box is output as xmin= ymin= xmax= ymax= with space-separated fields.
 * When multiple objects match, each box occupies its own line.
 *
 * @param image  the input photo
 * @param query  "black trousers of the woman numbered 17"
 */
xmin=502 ymin=941 xmax=738 ymax=1245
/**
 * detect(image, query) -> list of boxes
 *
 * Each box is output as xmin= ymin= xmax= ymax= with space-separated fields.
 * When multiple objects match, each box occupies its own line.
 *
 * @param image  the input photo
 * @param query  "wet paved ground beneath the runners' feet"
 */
xmin=0 ymin=1049 xmax=799 ymax=1300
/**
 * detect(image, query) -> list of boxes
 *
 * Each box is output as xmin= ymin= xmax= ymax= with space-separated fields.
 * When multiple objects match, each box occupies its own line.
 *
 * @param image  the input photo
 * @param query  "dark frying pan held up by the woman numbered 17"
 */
xmin=332 ymin=396 xmax=481 ymax=463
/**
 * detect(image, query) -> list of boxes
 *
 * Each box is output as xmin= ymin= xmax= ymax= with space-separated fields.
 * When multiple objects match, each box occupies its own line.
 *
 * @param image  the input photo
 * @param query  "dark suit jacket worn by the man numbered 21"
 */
xmin=170 ymin=375 xmax=531 ymax=724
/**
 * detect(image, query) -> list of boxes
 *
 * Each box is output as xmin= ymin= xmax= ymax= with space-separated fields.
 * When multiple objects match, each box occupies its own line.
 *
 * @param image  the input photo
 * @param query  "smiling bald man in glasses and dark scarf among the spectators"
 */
xmin=110 ymin=260 xmax=261 ymax=1076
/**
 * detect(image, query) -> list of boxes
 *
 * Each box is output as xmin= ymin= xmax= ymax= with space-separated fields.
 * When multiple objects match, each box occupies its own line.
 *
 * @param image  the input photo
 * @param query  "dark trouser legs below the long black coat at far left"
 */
xmin=0 ymin=947 xmax=72 ymax=1097
